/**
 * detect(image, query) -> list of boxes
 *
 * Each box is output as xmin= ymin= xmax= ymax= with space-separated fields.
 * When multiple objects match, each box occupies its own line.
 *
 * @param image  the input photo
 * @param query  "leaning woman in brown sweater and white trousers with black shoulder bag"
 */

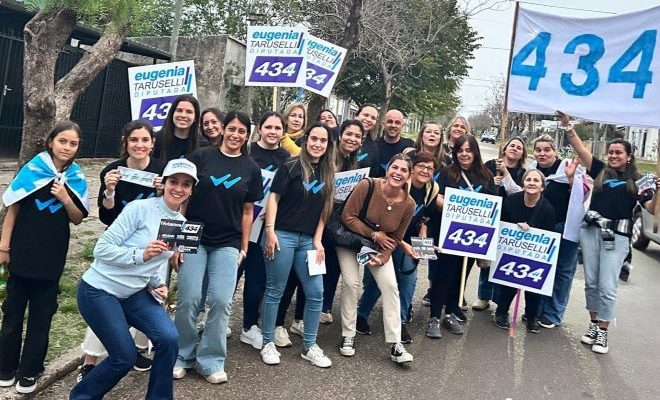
xmin=337 ymin=154 xmax=415 ymax=364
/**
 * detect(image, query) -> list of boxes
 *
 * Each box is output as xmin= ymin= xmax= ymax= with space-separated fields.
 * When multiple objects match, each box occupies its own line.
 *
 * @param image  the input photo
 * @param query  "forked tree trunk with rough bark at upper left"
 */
xmin=18 ymin=8 xmax=127 ymax=166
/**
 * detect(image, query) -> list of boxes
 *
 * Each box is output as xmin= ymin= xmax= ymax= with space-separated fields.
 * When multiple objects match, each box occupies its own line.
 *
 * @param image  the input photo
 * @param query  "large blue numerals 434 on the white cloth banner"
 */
xmin=511 ymin=29 xmax=658 ymax=99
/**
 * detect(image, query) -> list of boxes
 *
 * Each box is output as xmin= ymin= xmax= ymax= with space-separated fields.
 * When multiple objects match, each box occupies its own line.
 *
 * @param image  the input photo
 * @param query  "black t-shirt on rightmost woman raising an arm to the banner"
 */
xmin=588 ymin=157 xmax=639 ymax=220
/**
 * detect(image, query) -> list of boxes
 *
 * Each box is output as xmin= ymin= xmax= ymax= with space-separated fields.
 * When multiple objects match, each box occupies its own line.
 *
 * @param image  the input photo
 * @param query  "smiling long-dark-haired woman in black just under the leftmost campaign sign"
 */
xmin=154 ymin=94 xmax=199 ymax=163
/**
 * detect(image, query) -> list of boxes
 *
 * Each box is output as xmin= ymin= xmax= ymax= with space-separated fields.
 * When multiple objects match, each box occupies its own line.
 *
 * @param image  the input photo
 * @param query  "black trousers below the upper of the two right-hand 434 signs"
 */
xmin=429 ymin=253 xmax=474 ymax=318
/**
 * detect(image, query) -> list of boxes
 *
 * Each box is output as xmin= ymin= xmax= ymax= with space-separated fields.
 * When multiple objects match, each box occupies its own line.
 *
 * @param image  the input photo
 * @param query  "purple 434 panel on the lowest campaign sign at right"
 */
xmin=493 ymin=254 xmax=552 ymax=290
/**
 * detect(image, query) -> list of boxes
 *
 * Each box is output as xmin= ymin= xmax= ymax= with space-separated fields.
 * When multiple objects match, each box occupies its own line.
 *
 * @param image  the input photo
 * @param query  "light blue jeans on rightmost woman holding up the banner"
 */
xmin=580 ymin=226 xmax=630 ymax=321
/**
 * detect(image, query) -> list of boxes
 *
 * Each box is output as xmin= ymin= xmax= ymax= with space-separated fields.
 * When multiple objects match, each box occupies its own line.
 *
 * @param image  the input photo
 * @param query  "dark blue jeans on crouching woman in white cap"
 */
xmin=69 ymin=279 xmax=179 ymax=400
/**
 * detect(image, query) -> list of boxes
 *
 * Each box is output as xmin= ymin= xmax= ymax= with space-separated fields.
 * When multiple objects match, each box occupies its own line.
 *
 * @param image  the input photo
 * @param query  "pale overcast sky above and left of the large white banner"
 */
xmin=460 ymin=0 xmax=660 ymax=115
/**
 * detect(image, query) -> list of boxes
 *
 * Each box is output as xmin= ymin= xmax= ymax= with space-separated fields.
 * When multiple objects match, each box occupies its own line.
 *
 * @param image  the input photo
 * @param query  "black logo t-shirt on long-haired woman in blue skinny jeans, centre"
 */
xmin=270 ymin=158 xmax=334 ymax=236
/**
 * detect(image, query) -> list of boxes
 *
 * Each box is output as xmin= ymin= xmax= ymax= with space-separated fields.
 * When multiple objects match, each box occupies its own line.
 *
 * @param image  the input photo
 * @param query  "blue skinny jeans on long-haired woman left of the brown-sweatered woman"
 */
xmin=261 ymin=230 xmax=323 ymax=349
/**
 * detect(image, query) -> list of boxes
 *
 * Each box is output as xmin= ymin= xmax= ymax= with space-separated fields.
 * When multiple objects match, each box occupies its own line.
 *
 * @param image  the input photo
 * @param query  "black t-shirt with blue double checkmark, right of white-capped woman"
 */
xmin=186 ymin=147 xmax=264 ymax=249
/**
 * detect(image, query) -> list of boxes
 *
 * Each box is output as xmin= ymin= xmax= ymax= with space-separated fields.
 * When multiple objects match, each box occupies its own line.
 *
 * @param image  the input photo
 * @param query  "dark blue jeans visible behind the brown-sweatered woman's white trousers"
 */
xmin=358 ymin=247 xmax=417 ymax=323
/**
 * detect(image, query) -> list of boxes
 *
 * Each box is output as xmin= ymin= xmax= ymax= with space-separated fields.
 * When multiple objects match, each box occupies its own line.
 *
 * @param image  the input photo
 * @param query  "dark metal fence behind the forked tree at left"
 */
xmin=0 ymin=27 xmax=133 ymax=157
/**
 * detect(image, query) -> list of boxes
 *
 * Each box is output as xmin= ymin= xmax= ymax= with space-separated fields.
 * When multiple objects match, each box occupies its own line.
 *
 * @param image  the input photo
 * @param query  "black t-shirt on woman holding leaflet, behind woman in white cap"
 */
xmin=97 ymin=157 xmax=165 ymax=226
